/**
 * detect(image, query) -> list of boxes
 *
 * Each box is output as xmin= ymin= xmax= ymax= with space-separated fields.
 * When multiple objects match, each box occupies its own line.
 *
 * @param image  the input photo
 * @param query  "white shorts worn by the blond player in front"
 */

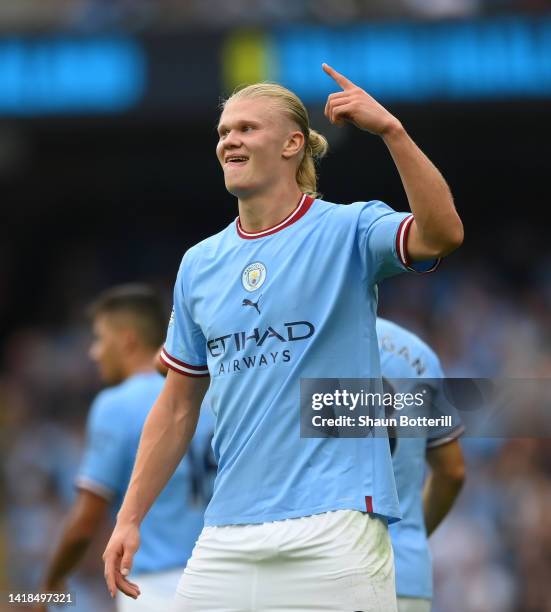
xmin=171 ymin=510 xmax=396 ymax=612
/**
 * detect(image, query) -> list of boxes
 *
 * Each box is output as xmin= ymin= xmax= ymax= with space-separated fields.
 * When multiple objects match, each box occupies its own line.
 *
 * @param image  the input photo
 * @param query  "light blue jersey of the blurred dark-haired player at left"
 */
xmin=77 ymin=372 xmax=213 ymax=573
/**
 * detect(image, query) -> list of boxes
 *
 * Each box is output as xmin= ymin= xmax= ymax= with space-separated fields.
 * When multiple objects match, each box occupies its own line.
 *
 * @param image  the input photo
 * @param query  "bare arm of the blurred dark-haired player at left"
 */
xmin=39 ymin=489 xmax=109 ymax=611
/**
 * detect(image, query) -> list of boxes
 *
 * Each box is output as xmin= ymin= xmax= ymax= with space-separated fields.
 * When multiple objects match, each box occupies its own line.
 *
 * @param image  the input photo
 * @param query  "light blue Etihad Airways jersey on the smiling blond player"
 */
xmin=162 ymin=196 xmax=430 ymax=525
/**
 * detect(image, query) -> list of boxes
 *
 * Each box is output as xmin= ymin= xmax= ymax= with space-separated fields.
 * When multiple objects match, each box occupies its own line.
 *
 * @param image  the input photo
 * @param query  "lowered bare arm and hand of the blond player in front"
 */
xmin=103 ymin=371 xmax=209 ymax=599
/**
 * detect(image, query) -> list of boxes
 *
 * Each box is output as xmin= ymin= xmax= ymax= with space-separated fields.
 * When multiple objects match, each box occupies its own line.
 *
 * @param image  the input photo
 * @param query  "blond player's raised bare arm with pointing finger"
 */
xmin=323 ymin=64 xmax=463 ymax=261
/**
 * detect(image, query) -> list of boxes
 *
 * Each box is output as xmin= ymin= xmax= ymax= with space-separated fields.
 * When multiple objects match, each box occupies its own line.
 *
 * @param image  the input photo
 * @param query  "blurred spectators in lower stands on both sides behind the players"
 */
xmin=0 ymin=266 xmax=551 ymax=612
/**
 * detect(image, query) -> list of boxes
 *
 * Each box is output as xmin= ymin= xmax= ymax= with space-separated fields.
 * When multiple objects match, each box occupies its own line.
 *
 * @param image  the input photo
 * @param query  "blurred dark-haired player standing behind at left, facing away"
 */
xmin=38 ymin=285 xmax=215 ymax=612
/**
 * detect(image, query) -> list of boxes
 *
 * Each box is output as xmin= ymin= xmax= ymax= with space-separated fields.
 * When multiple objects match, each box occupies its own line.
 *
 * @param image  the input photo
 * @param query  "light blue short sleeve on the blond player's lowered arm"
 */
xmin=161 ymin=251 xmax=209 ymax=377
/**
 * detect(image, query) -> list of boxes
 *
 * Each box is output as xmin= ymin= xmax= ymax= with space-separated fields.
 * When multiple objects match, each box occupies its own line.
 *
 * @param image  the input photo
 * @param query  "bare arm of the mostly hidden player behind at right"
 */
xmin=423 ymin=440 xmax=465 ymax=536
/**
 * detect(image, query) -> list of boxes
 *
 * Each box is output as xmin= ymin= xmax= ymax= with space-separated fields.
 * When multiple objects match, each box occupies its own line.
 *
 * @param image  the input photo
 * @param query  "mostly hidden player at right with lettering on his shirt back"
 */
xmin=377 ymin=318 xmax=465 ymax=612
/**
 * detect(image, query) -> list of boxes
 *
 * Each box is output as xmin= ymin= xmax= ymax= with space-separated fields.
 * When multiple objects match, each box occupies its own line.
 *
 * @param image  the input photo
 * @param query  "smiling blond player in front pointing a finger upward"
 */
xmin=103 ymin=65 xmax=463 ymax=612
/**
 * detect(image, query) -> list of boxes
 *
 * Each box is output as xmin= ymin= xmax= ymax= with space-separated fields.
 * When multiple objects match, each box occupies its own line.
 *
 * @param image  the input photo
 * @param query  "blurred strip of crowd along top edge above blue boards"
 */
xmin=0 ymin=0 xmax=549 ymax=31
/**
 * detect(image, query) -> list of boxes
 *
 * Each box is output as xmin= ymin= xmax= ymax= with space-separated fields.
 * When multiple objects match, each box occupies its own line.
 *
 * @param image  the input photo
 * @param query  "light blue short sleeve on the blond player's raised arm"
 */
xmin=357 ymin=200 xmax=440 ymax=283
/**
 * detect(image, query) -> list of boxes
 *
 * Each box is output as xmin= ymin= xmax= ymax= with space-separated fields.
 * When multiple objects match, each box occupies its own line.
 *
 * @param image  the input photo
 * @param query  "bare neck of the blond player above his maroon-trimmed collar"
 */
xmin=238 ymin=183 xmax=302 ymax=232
